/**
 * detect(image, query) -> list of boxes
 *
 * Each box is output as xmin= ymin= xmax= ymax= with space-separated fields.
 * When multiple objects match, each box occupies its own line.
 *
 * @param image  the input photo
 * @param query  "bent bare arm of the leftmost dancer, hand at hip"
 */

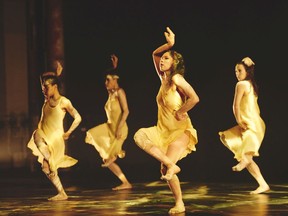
xmin=61 ymin=98 xmax=82 ymax=140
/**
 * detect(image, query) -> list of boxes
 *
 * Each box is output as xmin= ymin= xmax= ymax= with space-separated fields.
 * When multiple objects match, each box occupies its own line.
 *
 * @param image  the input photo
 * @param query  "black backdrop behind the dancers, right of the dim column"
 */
xmin=45 ymin=0 xmax=288 ymax=186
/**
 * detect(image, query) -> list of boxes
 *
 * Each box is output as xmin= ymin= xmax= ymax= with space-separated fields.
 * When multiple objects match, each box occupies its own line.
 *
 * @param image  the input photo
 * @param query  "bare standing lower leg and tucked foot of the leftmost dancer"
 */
xmin=42 ymin=160 xmax=68 ymax=201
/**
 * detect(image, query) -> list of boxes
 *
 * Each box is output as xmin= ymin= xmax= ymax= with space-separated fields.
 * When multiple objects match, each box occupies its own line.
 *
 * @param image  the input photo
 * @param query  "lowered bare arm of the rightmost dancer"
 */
xmin=233 ymin=81 xmax=246 ymax=129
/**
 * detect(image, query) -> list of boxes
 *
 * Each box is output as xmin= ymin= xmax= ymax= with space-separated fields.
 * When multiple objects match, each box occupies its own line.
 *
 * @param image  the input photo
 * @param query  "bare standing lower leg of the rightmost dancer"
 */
xmin=247 ymin=159 xmax=270 ymax=194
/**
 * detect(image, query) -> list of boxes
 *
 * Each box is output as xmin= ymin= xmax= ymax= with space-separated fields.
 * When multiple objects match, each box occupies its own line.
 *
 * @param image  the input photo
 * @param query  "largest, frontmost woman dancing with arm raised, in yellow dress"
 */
xmin=134 ymin=27 xmax=199 ymax=214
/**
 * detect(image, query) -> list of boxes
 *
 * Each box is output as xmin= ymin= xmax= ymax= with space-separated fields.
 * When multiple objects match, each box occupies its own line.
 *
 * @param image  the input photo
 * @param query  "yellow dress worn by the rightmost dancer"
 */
xmin=219 ymin=84 xmax=265 ymax=161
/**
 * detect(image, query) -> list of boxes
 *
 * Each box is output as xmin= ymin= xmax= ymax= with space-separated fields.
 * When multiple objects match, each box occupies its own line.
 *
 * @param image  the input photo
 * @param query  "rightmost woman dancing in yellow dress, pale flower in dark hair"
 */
xmin=219 ymin=57 xmax=270 ymax=194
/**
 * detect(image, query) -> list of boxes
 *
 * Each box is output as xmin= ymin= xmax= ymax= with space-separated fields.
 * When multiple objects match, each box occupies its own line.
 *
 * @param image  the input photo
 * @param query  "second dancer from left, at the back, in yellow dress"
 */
xmin=85 ymin=54 xmax=132 ymax=190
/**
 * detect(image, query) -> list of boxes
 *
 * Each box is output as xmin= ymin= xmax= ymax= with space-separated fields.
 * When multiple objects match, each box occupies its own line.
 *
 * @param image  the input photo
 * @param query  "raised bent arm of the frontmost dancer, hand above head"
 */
xmin=152 ymin=27 xmax=175 ymax=79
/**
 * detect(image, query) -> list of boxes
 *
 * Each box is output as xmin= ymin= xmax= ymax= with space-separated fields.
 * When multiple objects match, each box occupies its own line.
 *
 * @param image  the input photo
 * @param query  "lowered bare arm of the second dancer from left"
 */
xmin=116 ymin=89 xmax=129 ymax=139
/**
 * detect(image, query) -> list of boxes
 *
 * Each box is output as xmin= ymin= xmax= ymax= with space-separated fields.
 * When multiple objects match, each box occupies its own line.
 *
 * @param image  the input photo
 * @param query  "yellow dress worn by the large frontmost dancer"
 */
xmin=134 ymin=84 xmax=198 ymax=160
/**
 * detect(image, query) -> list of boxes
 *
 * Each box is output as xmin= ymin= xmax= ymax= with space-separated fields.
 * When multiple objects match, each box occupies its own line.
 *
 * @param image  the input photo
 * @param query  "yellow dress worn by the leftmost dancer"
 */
xmin=27 ymin=96 xmax=77 ymax=171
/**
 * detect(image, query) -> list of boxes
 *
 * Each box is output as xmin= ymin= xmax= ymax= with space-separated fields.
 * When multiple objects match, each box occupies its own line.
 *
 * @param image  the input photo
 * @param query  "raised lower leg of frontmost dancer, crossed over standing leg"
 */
xmin=134 ymin=129 xmax=181 ymax=181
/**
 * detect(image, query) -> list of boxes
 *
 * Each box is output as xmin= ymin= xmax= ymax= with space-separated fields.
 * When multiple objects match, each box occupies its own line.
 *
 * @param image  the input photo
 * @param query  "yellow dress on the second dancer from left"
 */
xmin=85 ymin=91 xmax=128 ymax=159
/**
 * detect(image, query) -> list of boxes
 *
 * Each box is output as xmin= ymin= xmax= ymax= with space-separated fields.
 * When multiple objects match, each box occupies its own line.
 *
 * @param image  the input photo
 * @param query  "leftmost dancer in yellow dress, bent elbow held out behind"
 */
xmin=27 ymin=62 xmax=81 ymax=201
